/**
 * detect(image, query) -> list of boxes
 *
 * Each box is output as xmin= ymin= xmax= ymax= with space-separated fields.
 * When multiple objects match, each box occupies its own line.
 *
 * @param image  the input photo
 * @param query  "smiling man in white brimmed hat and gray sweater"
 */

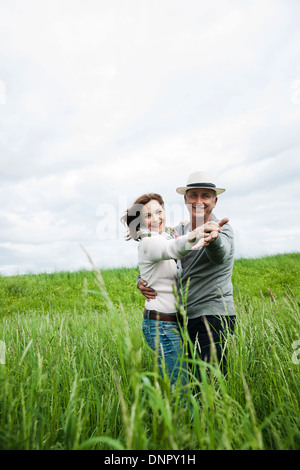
xmin=138 ymin=171 xmax=236 ymax=372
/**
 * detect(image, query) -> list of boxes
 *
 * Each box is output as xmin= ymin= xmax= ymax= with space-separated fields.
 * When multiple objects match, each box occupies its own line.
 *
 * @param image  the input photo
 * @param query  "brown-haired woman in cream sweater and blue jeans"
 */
xmin=122 ymin=193 xmax=221 ymax=385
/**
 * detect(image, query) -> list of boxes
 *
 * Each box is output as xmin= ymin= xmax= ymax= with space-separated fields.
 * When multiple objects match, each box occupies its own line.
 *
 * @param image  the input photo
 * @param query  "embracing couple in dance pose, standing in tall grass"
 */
xmin=122 ymin=171 xmax=235 ymax=385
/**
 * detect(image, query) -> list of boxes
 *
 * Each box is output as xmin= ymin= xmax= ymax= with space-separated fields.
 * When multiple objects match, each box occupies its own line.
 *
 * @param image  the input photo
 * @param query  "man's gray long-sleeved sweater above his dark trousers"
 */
xmin=175 ymin=214 xmax=236 ymax=318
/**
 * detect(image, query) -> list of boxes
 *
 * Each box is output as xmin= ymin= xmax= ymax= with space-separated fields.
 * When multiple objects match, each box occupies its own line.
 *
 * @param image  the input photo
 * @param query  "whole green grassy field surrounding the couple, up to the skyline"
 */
xmin=0 ymin=254 xmax=300 ymax=450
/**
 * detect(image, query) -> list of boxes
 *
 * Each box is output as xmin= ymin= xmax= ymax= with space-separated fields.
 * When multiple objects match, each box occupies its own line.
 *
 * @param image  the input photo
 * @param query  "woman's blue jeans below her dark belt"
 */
xmin=143 ymin=318 xmax=186 ymax=386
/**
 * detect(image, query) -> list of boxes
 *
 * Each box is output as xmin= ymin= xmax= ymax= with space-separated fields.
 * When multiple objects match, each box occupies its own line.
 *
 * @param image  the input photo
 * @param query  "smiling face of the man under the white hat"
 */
xmin=184 ymin=188 xmax=218 ymax=226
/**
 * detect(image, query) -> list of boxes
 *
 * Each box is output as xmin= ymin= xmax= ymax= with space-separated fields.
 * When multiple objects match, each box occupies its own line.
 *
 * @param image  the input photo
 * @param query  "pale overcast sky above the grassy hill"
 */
xmin=0 ymin=0 xmax=300 ymax=275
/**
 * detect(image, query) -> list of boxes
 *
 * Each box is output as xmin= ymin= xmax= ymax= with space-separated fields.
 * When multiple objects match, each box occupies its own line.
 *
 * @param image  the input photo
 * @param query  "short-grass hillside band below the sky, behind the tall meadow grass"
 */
xmin=0 ymin=253 xmax=300 ymax=316
